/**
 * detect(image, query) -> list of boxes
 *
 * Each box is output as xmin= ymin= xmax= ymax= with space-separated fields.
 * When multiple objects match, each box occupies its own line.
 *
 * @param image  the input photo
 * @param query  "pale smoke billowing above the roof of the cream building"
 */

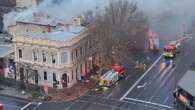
xmin=4 ymin=0 xmax=108 ymax=30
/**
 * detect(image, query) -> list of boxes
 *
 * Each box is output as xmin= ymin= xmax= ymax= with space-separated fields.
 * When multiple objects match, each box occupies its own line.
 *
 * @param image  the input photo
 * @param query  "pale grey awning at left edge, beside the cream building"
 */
xmin=0 ymin=44 xmax=14 ymax=58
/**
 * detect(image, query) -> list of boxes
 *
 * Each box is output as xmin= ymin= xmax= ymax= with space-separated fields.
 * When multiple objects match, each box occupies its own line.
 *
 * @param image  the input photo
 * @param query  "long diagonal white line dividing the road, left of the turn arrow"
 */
xmin=120 ymin=55 xmax=162 ymax=101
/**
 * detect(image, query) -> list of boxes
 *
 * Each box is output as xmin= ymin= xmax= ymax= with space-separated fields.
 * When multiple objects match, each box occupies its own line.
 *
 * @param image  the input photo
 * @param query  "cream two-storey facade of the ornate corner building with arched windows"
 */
xmin=9 ymin=24 xmax=92 ymax=89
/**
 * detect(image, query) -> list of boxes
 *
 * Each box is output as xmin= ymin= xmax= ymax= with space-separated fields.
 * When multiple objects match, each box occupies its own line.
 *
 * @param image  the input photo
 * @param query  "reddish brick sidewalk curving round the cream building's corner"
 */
xmin=49 ymin=79 xmax=96 ymax=101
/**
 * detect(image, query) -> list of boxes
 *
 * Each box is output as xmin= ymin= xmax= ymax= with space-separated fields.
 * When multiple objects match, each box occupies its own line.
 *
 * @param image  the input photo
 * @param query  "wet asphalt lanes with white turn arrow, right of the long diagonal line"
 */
xmin=122 ymin=36 xmax=195 ymax=107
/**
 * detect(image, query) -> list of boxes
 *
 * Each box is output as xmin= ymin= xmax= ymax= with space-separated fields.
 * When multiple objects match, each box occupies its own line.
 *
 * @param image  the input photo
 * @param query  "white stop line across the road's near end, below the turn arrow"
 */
xmin=125 ymin=97 xmax=173 ymax=109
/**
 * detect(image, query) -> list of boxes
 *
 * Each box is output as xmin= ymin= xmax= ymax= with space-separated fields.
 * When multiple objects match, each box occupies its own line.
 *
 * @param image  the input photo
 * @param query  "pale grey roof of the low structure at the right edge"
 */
xmin=178 ymin=70 xmax=195 ymax=96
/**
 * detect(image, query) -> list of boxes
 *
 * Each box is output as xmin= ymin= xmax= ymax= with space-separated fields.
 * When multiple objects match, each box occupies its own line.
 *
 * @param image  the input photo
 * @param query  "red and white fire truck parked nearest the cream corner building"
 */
xmin=99 ymin=64 xmax=125 ymax=87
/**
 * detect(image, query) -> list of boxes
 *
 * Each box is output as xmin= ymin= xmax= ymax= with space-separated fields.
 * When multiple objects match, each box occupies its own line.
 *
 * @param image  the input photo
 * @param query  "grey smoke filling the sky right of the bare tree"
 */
xmin=136 ymin=0 xmax=195 ymax=39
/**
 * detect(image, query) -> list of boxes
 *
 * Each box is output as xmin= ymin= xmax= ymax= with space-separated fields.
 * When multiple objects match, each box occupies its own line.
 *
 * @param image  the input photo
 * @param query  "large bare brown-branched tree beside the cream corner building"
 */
xmin=89 ymin=0 xmax=148 ymax=66
